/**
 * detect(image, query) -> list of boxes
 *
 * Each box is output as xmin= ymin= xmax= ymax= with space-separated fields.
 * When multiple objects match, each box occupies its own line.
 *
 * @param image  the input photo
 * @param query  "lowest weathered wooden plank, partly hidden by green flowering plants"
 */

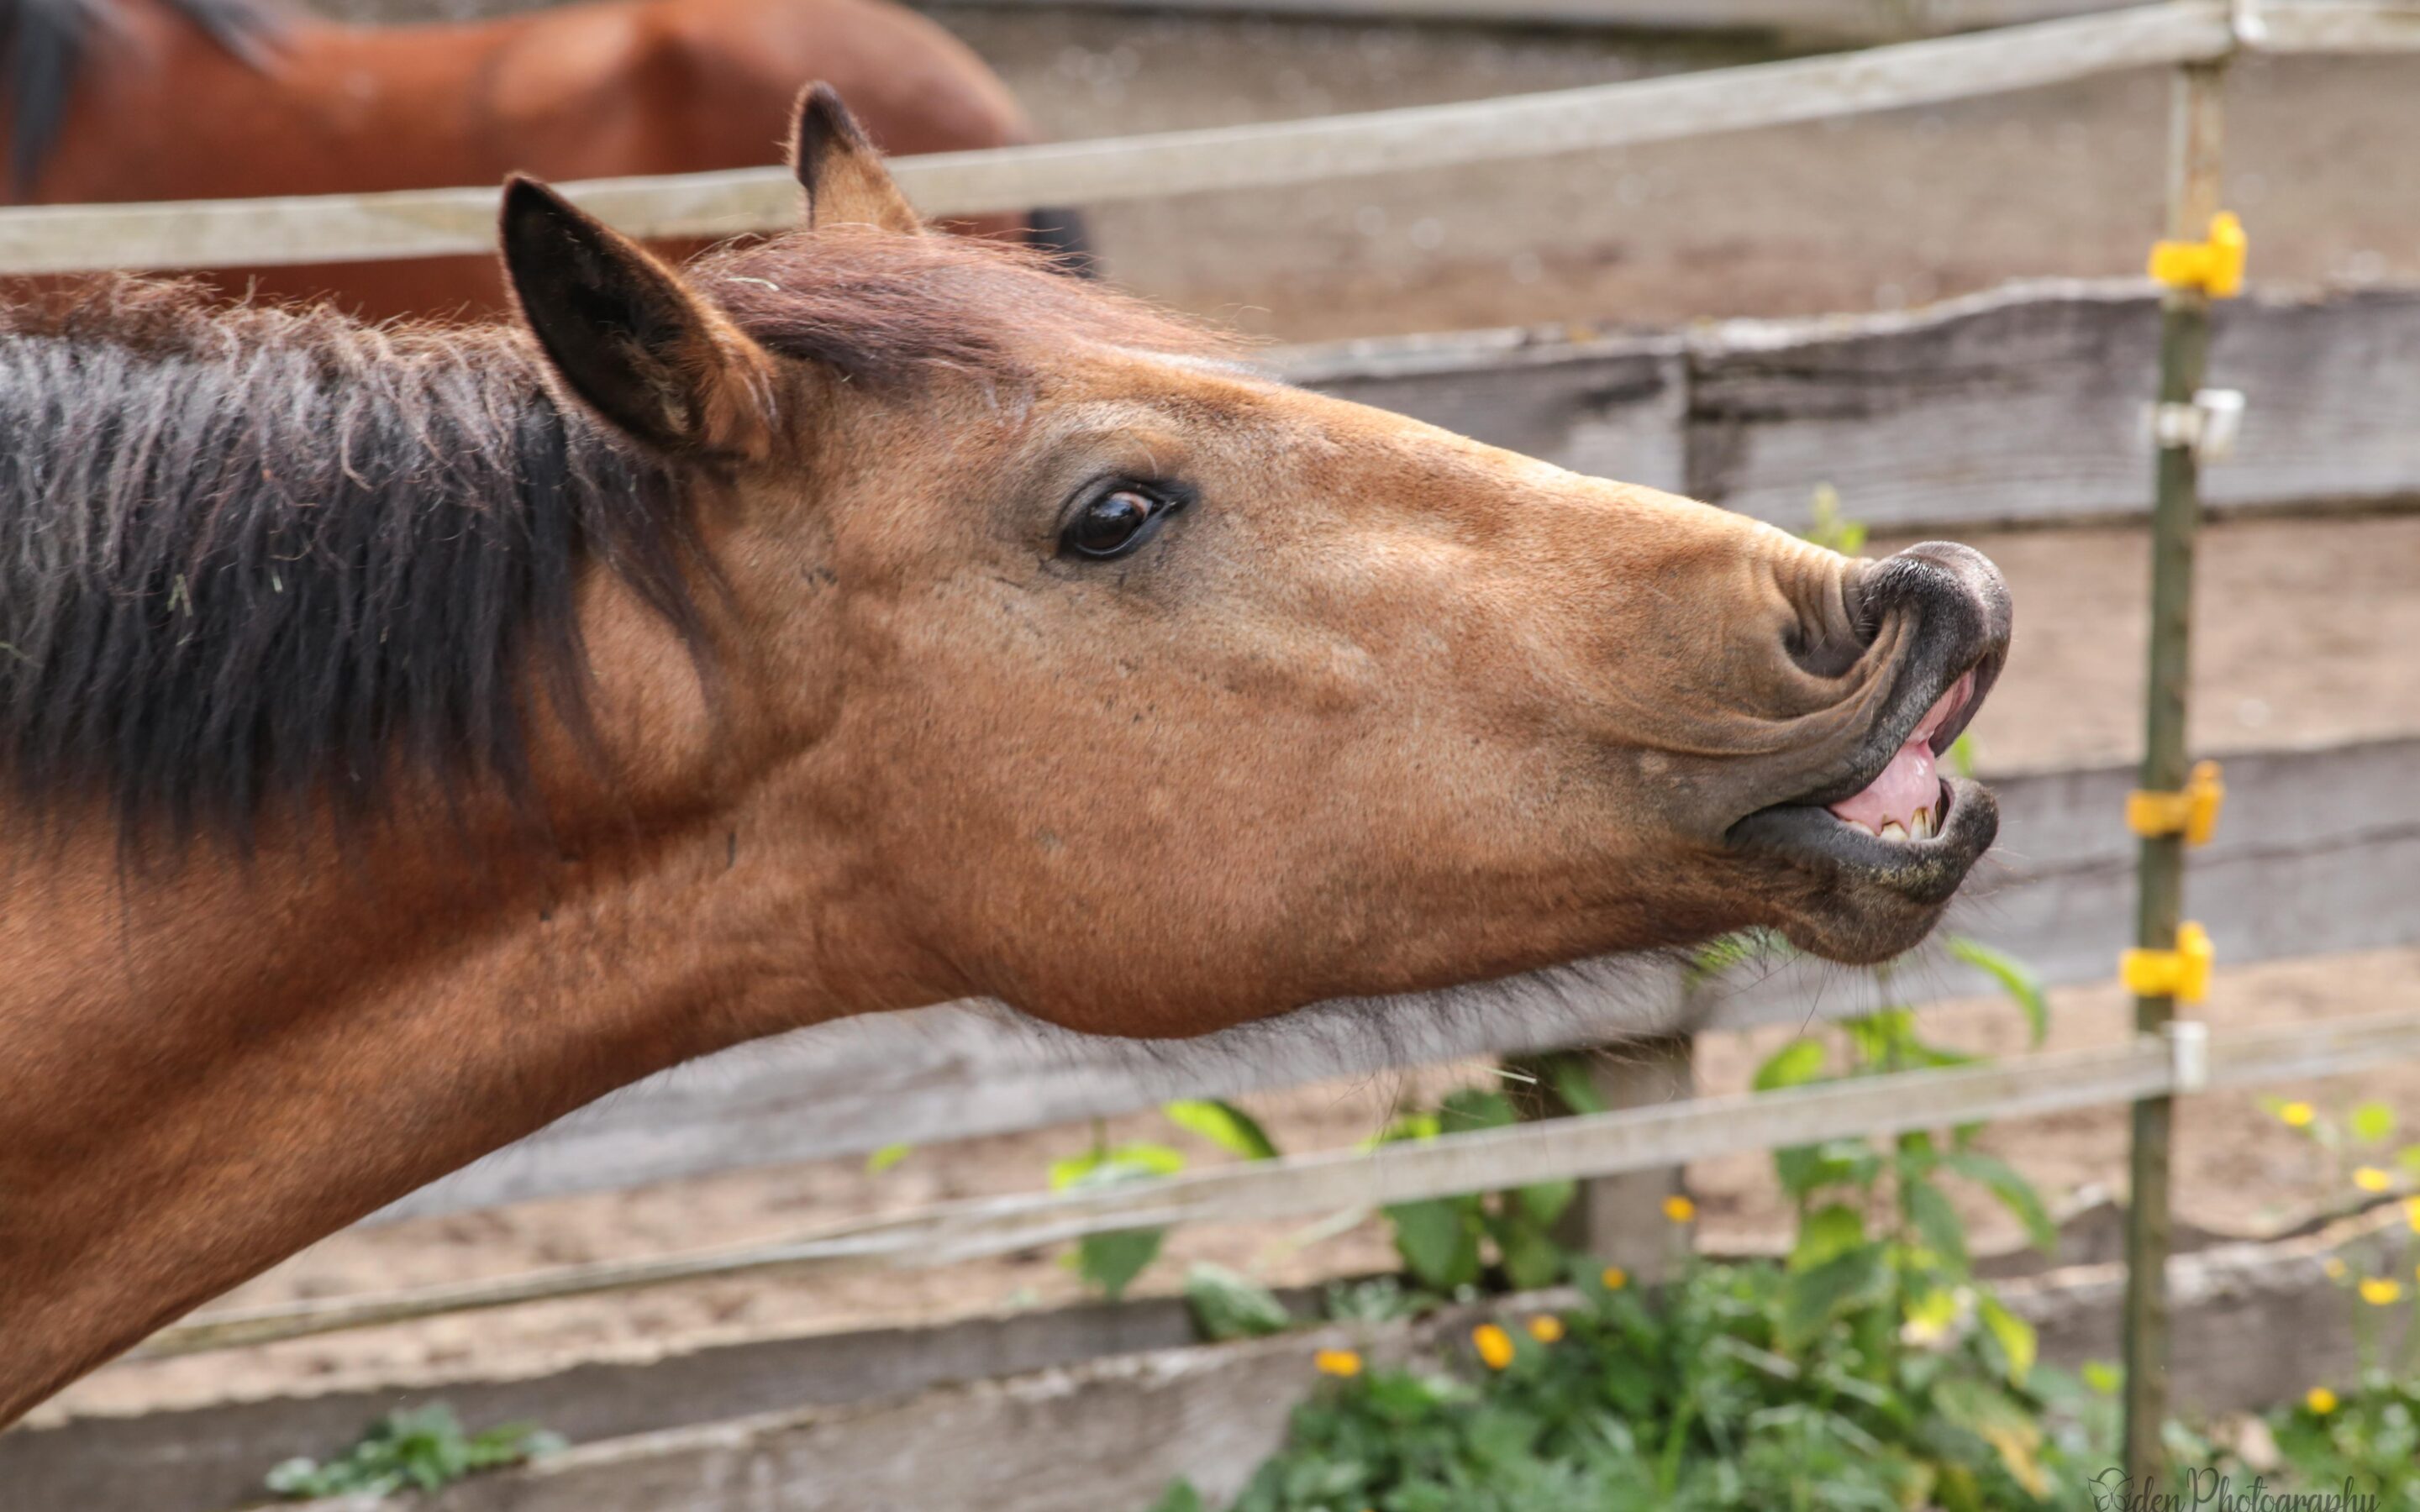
xmin=255 ymin=1210 xmax=2410 ymax=1512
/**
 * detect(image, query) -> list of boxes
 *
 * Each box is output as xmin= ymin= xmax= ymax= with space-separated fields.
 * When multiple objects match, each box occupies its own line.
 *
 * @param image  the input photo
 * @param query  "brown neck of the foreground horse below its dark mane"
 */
xmin=0 ymin=784 xmax=851 ymax=1422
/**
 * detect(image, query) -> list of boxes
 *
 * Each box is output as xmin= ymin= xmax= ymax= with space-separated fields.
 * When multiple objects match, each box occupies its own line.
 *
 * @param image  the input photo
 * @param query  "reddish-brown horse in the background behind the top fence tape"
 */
xmin=0 ymin=0 xmax=1084 ymax=319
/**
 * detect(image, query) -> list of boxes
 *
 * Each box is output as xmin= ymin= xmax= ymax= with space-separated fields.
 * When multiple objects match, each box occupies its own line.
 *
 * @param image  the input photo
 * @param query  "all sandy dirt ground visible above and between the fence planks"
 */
xmin=39 ymin=0 xmax=2420 ymax=1418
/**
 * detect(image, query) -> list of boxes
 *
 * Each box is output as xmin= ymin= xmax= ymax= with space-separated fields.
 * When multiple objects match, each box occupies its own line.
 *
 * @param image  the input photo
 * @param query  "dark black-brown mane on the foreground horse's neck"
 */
xmin=0 ymin=281 xmax=699 ymax=839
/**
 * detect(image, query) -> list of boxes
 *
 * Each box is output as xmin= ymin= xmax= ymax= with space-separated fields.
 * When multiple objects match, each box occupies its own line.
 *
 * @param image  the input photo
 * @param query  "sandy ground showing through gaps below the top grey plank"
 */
xmin=44 ymin=517 xmax=2420 ymax=1415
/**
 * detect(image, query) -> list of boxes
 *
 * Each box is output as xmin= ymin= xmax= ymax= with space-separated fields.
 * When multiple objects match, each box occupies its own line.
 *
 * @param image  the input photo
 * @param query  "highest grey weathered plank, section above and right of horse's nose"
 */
xmin=1686 ymin=286 xmax=2420 ymax=530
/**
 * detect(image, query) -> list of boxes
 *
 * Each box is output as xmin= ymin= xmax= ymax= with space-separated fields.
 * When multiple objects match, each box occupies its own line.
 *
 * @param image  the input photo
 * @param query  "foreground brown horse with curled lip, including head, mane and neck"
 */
xmin=0 ymin=92 xmax=2008 ymax=1422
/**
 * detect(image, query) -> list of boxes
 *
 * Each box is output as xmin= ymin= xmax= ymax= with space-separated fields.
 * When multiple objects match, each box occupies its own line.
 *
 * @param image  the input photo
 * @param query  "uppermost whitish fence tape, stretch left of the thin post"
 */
xmin=0 ymin=0 xmax=2233 ymax=273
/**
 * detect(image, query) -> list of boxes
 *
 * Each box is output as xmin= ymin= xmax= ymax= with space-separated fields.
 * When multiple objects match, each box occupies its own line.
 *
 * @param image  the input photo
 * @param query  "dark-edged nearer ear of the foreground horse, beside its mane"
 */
xmin=503 ymin=174 xmax=772 ymax=459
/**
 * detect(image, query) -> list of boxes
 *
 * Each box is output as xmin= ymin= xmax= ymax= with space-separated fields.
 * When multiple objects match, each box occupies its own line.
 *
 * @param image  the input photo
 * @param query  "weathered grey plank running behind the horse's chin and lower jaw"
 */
xmin=373 ymin=740 xmax=2420 ymax=1221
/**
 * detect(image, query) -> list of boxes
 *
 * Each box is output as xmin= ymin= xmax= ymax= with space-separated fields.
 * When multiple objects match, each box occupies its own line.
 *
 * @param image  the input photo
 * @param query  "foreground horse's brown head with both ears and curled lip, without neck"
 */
xmin=503 ymin=92 xmax=2008 ymax=1036
